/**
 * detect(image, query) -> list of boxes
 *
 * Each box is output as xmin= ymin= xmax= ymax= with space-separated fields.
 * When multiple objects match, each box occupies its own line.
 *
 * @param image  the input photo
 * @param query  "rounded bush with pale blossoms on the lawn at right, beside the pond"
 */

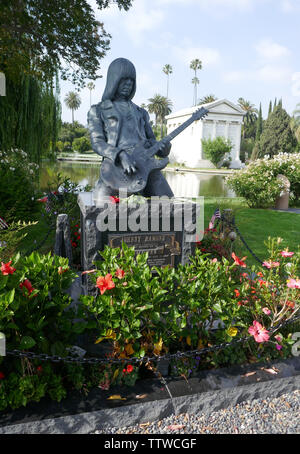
xmin=226 ymin=153 xmax=300 ymax=208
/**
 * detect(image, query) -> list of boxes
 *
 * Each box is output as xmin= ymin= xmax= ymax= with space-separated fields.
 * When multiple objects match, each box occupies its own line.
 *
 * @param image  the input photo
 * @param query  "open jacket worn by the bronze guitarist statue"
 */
xmin=88 ymin=100 xmax=156 ymax=163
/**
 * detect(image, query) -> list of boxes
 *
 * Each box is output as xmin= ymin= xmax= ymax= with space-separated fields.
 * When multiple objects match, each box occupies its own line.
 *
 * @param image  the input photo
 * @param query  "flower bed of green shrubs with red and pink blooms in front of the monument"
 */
xmin=0 ymin=239 xmax=300 ymax=410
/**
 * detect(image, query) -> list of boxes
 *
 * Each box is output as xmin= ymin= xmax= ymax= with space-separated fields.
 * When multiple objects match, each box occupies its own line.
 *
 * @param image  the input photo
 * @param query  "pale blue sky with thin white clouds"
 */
xmin=61 ymin=0 xmax=300 ymax=124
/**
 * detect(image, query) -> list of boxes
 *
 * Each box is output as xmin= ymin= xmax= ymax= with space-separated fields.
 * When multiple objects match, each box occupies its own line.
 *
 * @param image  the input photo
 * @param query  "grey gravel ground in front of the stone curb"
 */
xmin=94 ymin=390 xmax=300 ymax=434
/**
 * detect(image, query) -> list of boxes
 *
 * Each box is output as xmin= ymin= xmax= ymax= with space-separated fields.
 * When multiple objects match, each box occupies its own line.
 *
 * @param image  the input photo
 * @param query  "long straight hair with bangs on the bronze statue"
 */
xmin=102 ymin=58 xmax=136 ymax=101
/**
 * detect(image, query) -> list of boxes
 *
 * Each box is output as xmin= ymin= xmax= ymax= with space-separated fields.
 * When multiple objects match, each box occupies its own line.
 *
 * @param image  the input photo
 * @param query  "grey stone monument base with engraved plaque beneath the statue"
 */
xmin=78 ymin=192 xmax=200 ymax=294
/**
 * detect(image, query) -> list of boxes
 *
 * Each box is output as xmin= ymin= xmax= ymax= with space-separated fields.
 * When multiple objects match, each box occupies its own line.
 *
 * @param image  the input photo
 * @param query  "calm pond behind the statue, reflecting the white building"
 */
xmin=40 ymin=161 xmax=235 ymax=197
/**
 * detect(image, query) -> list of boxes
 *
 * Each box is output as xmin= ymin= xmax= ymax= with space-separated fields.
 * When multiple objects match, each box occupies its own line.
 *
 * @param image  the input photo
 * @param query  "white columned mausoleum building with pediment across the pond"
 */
xmin=166 ymin=99 xmax=245 ymax=168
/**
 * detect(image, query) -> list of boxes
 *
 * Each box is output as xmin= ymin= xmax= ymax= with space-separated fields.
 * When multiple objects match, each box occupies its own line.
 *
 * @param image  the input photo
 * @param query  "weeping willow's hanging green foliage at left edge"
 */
xmin=0 ymin=74 xmax=61 ymax=163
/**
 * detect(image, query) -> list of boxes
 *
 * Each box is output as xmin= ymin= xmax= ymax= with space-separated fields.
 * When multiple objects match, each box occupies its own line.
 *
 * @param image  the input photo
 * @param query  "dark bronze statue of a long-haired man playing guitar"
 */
xmin=88 ymin=58 xmax=173 ymax=197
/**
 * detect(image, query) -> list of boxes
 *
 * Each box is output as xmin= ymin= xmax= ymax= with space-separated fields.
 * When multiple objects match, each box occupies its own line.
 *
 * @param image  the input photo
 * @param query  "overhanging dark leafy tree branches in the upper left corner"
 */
xmin=0 ymin=0 xmax=132 ymax=86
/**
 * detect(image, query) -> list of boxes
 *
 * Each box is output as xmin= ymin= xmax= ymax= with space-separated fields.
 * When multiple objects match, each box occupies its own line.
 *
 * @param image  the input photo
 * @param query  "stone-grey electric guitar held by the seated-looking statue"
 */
xmin=100 ymin=107 xmax=208 ymax=194
